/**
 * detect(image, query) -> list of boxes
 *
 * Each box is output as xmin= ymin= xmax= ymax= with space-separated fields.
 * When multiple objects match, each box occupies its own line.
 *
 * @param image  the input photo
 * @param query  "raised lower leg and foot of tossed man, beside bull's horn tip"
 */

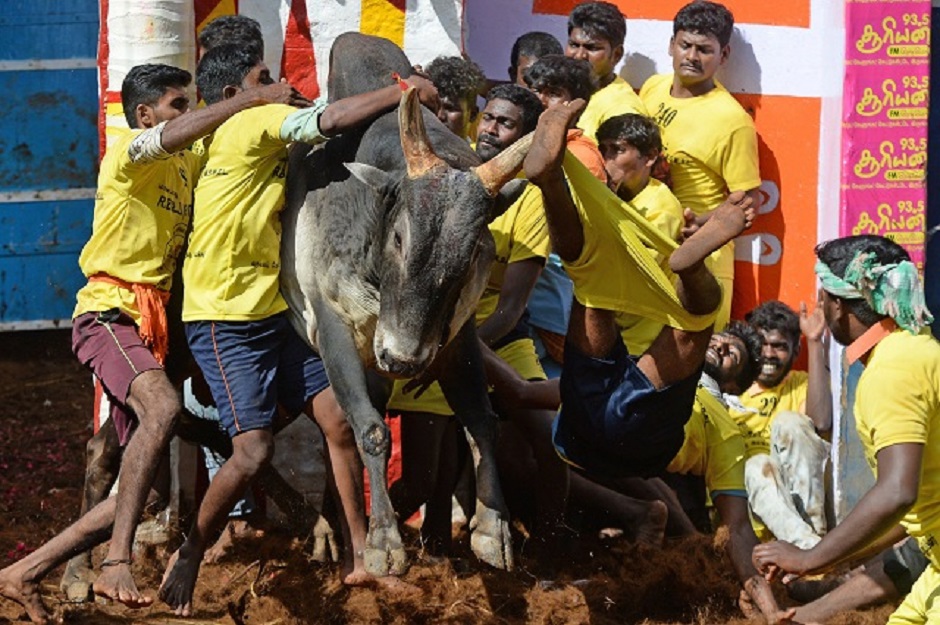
xmin=524 ymin=99 xmax=584 ymax=262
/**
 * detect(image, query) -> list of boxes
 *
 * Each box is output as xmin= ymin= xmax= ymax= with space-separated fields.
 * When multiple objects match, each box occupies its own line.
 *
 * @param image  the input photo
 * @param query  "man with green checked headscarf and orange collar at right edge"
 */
xmin=753 ymin=235 xmax=940 ymax=625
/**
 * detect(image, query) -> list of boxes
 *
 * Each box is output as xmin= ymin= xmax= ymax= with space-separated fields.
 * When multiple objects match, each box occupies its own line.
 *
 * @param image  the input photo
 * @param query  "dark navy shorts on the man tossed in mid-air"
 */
xmin=552 ymin=341 xmax=699 ymax=478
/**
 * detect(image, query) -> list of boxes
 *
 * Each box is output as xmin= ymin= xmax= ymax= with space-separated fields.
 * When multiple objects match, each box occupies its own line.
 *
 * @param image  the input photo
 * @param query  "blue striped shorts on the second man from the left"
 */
xmin=186 ymin=313 xmax=330 ymax=437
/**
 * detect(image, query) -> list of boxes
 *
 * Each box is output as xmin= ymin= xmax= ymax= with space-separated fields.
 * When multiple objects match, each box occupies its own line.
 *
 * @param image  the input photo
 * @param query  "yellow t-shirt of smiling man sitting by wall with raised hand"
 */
xmin=730 ymin=371 xmax=809 ymax=458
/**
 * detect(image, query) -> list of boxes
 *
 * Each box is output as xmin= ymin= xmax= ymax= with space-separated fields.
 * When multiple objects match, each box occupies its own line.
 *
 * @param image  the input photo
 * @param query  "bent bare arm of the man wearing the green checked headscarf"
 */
xmin=753 ymin=443 xmax=924 ymax=575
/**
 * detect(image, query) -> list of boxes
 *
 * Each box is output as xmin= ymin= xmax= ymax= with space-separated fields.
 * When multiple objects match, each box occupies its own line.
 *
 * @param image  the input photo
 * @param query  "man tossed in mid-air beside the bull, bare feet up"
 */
xmin=524 ymin=92 xmax=788 ymax=617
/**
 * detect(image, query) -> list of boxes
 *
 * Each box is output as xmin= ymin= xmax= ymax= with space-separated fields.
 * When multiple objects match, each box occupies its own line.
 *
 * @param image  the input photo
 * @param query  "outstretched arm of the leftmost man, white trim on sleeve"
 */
xmin=127 ymin=82 xmax=306 ymax=163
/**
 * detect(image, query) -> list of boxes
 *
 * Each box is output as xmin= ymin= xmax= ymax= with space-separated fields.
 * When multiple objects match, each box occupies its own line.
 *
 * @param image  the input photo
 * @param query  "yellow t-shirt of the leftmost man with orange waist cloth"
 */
xmin=72 ymin=130 xmax=198 ymax=324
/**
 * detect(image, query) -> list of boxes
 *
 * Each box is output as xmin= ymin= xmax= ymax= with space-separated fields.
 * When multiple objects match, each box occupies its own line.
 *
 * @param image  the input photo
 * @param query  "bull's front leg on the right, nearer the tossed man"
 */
xmin=439 ymin=320 xmax=513 ymax=570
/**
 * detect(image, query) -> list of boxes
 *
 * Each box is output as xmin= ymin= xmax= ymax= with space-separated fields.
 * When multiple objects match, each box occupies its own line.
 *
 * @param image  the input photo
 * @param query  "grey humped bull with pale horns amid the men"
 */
xmin=281 ymin=33 xmax=531 ymax=575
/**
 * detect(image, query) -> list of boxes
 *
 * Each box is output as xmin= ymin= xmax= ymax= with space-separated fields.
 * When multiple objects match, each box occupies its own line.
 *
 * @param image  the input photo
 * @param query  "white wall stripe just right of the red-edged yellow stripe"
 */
xmin=404 ymin=0 xmax=464 ymax=65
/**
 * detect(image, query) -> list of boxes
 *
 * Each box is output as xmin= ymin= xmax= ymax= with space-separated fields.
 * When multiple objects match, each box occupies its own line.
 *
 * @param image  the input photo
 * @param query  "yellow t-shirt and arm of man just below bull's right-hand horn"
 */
xmin=476 ymin=184 xmax=551 ymax=325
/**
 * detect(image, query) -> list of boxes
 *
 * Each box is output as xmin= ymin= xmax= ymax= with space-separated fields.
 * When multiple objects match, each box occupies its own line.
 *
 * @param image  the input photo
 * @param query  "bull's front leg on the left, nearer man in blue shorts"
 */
xmin=313 ymin=301 xmax=408 ymax=577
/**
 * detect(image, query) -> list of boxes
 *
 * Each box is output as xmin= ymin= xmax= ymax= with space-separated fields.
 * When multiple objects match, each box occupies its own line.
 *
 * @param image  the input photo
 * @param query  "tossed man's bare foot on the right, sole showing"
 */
xmin=669 ymin=191 xmax=755 ymax=273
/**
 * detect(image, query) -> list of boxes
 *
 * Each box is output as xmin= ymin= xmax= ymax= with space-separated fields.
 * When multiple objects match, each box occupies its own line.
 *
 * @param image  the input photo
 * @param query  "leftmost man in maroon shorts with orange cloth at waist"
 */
xmin=2 ymin=64 xmax=302 ymax=622
